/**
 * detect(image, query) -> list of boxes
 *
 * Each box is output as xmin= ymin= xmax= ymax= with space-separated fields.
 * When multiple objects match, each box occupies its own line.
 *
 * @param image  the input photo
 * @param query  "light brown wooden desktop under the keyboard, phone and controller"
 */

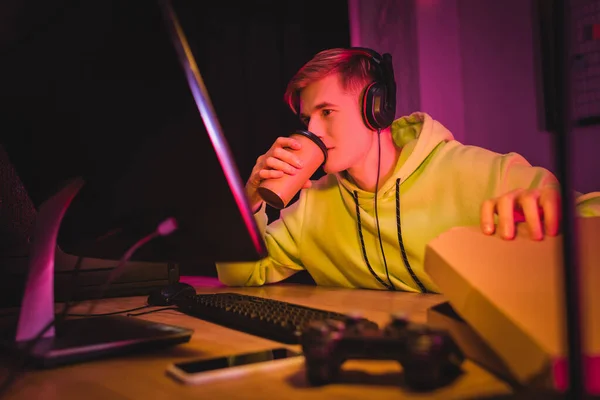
xmin=1 ymin=278 xmax=510 ymax=400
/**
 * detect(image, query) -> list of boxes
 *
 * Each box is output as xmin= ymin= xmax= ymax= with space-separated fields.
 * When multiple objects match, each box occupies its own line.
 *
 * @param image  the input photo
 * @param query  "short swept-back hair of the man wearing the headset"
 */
xmin=283 ymin=48 xmax=376 ymax=114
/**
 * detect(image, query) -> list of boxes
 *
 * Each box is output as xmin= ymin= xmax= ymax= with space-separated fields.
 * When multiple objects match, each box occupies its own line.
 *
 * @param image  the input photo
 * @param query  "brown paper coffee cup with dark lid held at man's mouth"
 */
xmin=258 ymin=129 xmax=327 ymax=209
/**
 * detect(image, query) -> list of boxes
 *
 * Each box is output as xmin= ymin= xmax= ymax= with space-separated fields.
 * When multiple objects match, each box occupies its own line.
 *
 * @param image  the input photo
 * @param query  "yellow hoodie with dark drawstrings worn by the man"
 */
xmin=216 ymin=113 xmax=600 ymax=292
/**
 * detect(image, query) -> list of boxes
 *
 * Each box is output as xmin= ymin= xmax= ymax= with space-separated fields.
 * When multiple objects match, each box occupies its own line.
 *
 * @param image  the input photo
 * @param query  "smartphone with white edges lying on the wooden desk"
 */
xmin=167 ymin=347 xmax=303 ymax=384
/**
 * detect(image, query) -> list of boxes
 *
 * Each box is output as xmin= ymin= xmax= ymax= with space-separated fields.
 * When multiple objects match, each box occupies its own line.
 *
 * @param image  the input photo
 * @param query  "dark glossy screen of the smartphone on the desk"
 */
xmin=175 ymin=347 xmax=301 ymax=374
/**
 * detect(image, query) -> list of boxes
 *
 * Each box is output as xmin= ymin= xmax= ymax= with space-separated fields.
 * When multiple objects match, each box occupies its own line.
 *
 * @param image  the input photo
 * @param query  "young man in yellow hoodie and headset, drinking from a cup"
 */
xmin=217 ymin=49 xmax=600 ymax=292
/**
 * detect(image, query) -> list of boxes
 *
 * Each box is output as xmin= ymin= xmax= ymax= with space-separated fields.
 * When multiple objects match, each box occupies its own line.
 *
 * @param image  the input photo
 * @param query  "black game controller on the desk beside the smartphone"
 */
xmin=301 ymin=316 xmax=464 ymax=391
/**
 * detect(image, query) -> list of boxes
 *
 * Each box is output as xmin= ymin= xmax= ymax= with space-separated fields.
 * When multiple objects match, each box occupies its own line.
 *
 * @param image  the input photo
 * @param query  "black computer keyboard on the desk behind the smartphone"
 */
xmin=176 ymin=293 xmax=377 ymax=344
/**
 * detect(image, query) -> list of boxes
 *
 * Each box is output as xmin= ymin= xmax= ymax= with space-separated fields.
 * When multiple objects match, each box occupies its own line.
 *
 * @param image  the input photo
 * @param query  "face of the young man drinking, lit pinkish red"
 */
xmin=300 ymin=74 xmax=374 ymax=173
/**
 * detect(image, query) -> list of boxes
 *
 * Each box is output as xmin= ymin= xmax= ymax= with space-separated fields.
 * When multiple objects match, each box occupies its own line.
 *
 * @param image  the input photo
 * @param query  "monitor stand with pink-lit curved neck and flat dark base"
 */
xmin=2 ymin=178 xmax=193 ymax=367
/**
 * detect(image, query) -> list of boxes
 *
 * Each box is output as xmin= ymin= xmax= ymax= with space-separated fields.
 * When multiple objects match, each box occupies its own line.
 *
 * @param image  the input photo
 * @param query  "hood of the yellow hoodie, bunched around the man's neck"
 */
xmin=336 ymin=112 xmax=454 ymax=196
